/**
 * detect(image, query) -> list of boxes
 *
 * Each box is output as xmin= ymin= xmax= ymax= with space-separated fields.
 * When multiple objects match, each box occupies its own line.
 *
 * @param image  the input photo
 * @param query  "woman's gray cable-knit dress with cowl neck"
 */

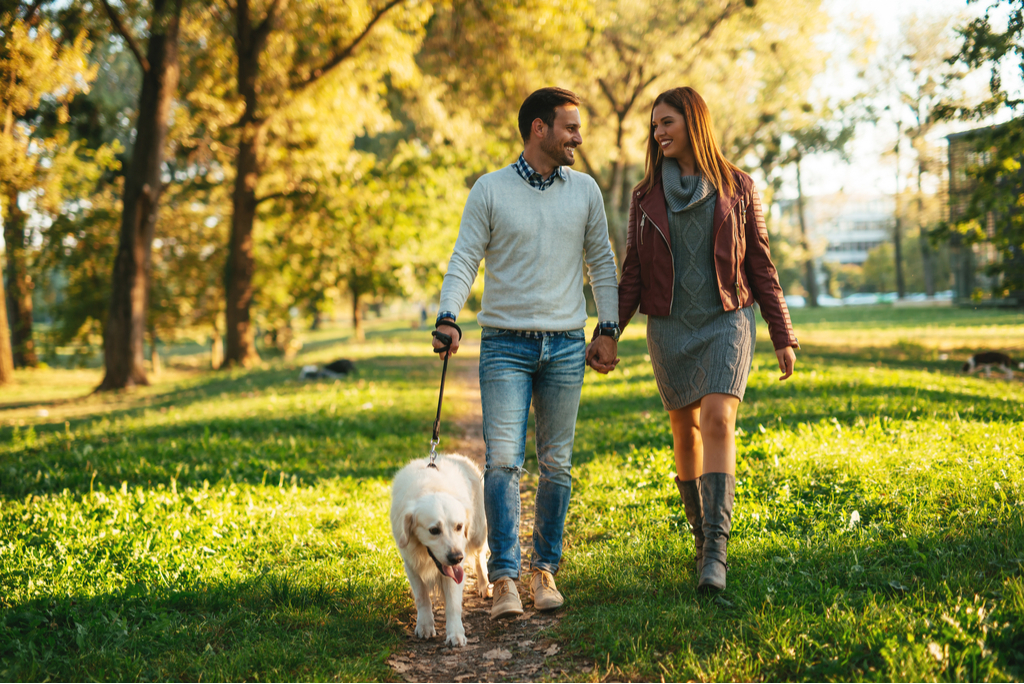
xmin=647 ymin=159 xmax=755 ymax=411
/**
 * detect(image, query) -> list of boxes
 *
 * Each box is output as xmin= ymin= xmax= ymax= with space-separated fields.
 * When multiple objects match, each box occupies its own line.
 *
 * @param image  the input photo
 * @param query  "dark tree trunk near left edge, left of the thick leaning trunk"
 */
xmin=3 ymin=188 xmax=39 ymax=368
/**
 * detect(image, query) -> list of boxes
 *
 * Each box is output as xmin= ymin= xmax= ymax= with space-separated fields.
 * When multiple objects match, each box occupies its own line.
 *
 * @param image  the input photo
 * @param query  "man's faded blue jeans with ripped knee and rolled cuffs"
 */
xmin=480 ymin=328 xmax=587 ymax=582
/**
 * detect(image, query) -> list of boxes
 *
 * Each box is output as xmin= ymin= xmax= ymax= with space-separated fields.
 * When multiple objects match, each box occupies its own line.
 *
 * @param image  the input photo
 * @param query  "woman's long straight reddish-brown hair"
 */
xmin=636 ymin=87 xmax=739 ymax=195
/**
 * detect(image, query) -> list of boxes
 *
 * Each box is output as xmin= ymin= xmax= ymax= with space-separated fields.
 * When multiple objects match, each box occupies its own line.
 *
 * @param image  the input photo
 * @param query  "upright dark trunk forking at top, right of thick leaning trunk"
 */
xmin=224 ymin=0 xmax=273 ymax=368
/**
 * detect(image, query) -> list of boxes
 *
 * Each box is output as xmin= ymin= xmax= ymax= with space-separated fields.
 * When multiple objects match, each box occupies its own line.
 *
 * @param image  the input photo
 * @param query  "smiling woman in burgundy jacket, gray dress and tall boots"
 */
xmin=592 ymin=88 xmax=799 ymax=592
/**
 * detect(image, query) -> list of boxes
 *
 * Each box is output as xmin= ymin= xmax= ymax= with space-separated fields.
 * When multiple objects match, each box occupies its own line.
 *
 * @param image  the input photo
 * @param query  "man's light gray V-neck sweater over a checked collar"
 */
xmin=439 ymin=166 xmax=618 ymax=331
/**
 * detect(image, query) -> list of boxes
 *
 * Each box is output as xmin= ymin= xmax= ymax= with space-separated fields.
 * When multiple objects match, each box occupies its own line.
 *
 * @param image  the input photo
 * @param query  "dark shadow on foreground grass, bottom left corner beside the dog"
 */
xmin=0 ymin=570 xmax=409 ymax=681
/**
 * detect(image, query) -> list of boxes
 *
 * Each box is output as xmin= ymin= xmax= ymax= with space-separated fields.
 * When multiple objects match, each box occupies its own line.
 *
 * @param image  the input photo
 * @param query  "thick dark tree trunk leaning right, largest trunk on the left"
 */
xmin=98 ymin=0 xmax=182 ymax=390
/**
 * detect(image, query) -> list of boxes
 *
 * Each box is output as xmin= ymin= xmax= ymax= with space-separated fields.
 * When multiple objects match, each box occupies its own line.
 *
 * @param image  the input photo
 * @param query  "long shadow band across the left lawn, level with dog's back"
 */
xmin=0 ymin=409 xmax=432 ymax=499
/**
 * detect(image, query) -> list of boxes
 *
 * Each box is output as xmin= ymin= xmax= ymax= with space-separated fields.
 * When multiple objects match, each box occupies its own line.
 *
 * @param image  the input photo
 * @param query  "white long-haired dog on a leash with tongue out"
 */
xmin=391 ymin=454 xmax=487 ymax=646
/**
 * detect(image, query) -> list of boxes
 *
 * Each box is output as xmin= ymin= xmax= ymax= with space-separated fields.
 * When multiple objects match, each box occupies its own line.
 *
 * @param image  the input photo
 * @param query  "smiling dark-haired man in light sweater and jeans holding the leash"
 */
xmin=434 ymin=88 xmax=618 ymax=618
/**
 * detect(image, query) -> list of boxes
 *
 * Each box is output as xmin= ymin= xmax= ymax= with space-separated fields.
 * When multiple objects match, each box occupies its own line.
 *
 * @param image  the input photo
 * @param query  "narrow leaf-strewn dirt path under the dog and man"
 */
xmin=388 ymin=342 xmax=594 ymax=682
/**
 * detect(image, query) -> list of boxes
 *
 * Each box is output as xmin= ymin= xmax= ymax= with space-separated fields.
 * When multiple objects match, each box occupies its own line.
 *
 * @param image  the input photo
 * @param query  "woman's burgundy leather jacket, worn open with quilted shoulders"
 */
xmin=618 ymin=172 xmax=800 ymax=349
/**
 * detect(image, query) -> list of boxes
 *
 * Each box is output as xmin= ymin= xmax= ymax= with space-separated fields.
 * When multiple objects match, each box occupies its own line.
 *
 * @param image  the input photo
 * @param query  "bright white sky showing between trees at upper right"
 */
xmin=780 ymin=0 xmax=1007 ymax=198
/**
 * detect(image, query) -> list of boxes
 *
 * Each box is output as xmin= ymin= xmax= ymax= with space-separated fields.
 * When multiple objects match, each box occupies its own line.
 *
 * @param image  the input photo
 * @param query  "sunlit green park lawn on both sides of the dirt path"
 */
xmin=0 ymin=307 xmax=1024 ymax=681
